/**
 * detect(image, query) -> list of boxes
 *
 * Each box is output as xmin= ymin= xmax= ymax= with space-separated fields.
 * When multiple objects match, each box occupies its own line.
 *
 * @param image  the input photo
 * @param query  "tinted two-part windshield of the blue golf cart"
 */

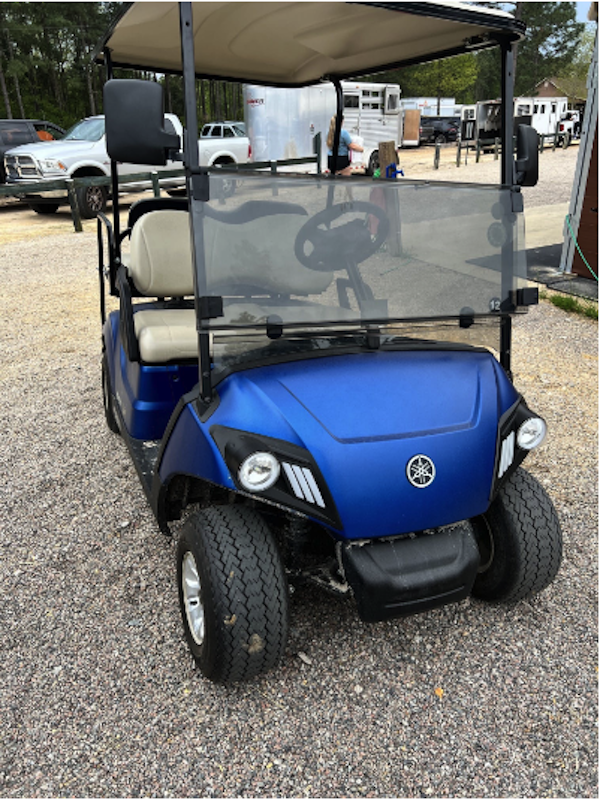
xmin=199 ymin=175 xmax=527 ymax=372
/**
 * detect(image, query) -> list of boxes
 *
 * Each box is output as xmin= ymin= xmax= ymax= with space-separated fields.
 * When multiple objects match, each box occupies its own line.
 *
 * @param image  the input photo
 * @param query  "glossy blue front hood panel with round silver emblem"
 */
xmin=214 ymin=351 xmax=518 ymax=539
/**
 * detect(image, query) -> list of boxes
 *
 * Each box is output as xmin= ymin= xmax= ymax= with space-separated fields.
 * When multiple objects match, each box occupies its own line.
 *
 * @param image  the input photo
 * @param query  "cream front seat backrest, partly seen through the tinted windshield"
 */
xmin=128 ymin=201 xmax=333 ymax=297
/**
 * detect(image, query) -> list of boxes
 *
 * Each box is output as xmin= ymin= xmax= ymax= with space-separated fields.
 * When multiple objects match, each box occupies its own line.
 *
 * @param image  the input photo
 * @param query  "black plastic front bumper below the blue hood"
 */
xmin=341 ymin=523 xmax=479 ymax=622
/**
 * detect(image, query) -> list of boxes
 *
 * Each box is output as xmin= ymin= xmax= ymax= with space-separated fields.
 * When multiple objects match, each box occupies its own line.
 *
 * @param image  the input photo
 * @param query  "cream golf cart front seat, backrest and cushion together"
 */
xmin=121 ymin=201 xmax=354 ymax=364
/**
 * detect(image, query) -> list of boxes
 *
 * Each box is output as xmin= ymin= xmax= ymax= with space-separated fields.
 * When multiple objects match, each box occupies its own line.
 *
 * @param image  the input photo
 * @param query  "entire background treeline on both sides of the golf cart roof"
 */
xmin=0 ymin=2 xmax=593 ymax=127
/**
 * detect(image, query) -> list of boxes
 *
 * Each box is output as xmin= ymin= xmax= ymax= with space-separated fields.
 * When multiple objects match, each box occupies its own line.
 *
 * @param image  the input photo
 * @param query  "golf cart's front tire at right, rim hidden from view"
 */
xmin=473 ymin=469 xmax=562 ymax=603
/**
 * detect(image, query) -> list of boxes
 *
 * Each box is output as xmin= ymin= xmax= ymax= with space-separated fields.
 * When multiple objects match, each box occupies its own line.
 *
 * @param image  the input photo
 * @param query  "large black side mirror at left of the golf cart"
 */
xmin=104 ymin=80 xmax=181 ymax=166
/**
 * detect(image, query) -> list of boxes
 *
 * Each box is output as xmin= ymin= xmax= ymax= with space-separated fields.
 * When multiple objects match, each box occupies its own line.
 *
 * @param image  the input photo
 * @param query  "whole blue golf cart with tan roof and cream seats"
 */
xmin=98 ymin=3 xmax=560 ymax=681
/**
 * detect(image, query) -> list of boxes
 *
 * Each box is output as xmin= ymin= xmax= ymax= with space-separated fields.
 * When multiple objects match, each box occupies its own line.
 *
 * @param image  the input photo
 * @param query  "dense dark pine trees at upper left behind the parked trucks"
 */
xmin=0 ymin=2 xmax=243 ymax=128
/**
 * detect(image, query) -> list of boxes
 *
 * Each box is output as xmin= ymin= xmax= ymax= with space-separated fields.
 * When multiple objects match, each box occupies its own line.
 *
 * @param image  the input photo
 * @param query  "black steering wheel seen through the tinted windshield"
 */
xmin=294 ymin=201 xmax=390 ymax=272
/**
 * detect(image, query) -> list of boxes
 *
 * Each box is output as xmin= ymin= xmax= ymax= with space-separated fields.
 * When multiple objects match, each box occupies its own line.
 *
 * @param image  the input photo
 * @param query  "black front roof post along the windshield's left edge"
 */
xmin=179 ymin=2 xmax=213 ymax=404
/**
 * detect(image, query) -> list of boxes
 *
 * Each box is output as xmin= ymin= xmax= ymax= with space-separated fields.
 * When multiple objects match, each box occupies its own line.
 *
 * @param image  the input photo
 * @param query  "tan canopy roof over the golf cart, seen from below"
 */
xmin=97 ymin=1 xmax=523 ymax=86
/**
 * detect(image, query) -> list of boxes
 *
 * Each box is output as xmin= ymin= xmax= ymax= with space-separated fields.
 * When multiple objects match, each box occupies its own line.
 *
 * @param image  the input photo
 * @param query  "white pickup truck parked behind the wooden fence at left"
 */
xmin=4 ymin=114 xmax=249 ymax=219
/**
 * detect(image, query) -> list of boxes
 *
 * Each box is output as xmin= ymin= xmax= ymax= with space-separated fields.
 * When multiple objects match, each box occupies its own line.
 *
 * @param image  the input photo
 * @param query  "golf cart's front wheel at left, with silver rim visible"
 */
xmin=177 ymin=505 xmax=288 ymax=683
